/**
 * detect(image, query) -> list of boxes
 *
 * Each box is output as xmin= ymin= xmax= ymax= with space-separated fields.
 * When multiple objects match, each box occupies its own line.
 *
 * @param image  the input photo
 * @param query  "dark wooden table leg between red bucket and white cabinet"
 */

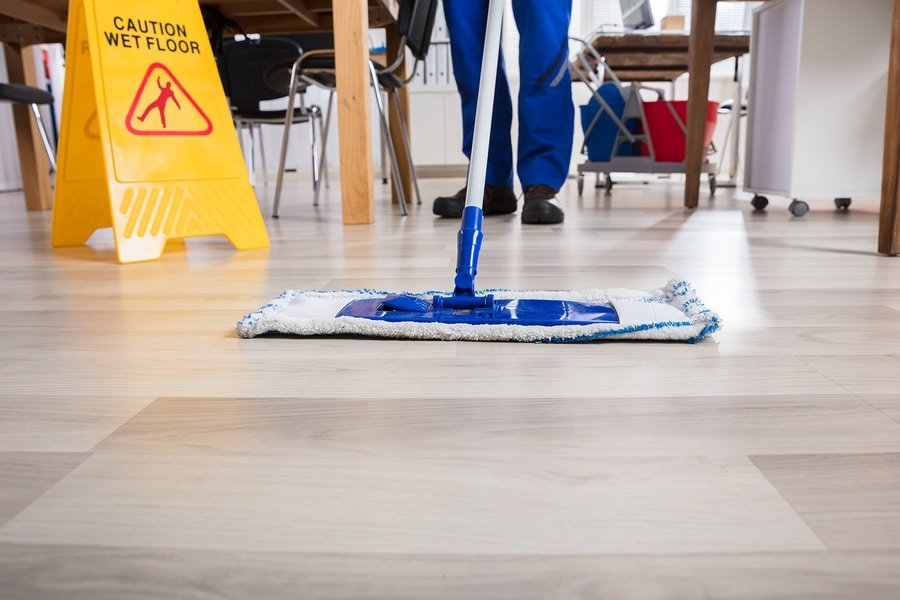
xmin=684 ymin=0 xmax=717 ymax=208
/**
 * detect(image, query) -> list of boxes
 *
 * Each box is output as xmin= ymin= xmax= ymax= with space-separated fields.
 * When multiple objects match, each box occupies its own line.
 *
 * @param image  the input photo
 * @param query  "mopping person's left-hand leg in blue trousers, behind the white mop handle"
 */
xmin=435 ymin=0 xmax=515 ymax=216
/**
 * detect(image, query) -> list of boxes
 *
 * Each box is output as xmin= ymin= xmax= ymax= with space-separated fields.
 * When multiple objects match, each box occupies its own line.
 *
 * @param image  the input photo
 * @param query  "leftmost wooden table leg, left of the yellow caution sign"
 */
xmin=5 ymin=44 xmax=53 ymax=210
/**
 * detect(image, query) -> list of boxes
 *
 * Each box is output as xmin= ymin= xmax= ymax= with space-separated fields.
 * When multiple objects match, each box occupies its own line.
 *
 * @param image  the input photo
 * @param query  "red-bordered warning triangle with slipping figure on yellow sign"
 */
xmin=125 ymin=63 xmax=212 ymax=135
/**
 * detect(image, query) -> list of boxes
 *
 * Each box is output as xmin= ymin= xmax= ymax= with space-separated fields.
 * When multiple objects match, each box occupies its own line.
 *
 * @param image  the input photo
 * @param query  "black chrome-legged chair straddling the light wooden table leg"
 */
xmin=272 ymin=0 xmax=438 ymax=218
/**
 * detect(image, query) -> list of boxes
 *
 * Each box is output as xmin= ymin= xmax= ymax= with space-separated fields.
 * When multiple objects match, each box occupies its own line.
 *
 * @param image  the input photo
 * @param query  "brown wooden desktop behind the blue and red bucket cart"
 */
xmin=576 ymin=32 xmax=750 ymax=81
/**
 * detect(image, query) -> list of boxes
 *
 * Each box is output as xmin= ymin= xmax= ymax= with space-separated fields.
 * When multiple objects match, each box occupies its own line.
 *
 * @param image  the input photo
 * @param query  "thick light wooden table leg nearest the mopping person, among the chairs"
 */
xmin=334 ymin=0 xmax=375 ymax=225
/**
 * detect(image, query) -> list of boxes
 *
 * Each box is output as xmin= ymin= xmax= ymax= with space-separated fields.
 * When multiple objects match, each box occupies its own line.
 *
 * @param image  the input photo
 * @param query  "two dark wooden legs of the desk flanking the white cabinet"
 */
xmin=684 ymin=0 xmax=900 ymax=256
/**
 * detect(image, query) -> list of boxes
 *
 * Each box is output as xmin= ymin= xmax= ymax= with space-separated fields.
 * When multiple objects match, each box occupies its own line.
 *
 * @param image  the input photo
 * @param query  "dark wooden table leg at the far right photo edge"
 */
xmin=878 ymin=0 xmax=900 ymax=256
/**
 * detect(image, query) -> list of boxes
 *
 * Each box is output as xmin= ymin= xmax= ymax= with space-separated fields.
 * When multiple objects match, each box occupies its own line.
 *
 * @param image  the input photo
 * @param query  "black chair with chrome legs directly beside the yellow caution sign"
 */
xmin=219 ymin=37 xmax=323 ymax=194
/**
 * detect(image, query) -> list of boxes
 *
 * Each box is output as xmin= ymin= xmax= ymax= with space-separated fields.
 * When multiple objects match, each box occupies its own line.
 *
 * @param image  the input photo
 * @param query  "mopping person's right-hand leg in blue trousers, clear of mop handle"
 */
xmin=513 ymin=0 xmax=575 ymax=223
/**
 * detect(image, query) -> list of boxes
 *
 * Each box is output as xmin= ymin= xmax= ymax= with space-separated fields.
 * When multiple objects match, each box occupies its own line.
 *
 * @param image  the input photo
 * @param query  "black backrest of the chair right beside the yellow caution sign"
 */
xmin=221 ymin=37 xmax=301 ymax=111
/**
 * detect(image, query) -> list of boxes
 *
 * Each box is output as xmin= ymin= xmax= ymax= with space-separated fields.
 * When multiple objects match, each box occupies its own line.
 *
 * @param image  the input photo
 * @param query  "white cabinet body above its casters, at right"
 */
xmin=744 ymin=0 xmax=893 ymax=207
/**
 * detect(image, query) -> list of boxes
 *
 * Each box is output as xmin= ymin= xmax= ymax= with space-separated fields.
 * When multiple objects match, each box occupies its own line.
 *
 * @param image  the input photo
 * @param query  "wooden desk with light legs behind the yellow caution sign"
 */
xmin=0 ymin=0 xmax=400 ymax=224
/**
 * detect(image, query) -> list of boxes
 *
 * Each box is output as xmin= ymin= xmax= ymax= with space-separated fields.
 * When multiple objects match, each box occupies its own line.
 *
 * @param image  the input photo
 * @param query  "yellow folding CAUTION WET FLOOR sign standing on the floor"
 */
xmin=51 ymin=0 xmax=269 ymax=262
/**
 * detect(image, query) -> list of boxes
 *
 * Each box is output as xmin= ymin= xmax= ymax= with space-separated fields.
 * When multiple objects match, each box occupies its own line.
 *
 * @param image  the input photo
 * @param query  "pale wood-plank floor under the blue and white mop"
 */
xmin=0 ymin=180 xmax=900 ymax=600
